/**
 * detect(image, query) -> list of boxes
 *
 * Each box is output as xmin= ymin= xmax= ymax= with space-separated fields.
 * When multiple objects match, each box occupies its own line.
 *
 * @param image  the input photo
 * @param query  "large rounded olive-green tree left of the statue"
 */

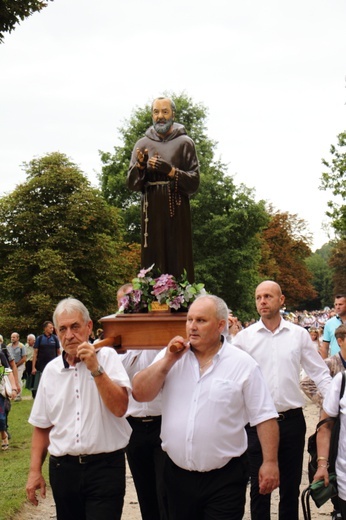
xmin=0 ymin=153 xmax=139 ymax=333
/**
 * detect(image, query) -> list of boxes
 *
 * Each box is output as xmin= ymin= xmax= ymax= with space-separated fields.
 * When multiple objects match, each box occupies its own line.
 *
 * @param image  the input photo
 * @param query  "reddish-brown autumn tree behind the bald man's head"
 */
xmin=260 ymin=207 xmax=317 ymax=308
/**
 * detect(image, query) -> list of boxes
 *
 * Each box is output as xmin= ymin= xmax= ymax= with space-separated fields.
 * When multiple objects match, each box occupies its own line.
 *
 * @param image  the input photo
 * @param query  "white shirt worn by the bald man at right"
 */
xmin=232 ymin=318 xmax=331 ymax=412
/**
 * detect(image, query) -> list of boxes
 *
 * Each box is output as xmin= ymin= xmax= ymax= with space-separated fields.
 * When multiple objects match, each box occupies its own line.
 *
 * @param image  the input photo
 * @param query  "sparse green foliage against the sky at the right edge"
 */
xmin=320 ymin=132 xmax=346 ymax=238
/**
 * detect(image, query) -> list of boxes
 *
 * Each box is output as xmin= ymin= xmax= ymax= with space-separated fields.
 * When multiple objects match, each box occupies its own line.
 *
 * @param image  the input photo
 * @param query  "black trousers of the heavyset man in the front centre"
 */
xmin=164 ymin=452 xmax=249 ymax=520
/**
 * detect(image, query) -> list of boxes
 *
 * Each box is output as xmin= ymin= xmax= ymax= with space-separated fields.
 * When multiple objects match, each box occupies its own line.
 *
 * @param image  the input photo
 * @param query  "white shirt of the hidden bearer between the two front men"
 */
xmin=119 ymin=349 xmax=161 ymax=417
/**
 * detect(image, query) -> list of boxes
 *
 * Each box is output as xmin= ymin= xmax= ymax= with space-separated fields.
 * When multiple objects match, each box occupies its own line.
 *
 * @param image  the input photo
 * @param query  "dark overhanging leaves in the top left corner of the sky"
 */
xmin=0 ymin=0 xmax=53 ymax=43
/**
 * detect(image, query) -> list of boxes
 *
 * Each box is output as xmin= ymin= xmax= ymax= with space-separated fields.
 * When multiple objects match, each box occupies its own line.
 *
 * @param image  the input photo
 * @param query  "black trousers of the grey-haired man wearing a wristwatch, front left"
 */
xmin=49 ymin=450 xmax=125 ymax=520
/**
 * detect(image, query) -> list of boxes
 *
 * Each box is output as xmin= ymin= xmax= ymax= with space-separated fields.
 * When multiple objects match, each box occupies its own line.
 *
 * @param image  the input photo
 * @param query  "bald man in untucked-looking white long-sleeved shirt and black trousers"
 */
xmin=233 ymin=281 xmax=331 ymax=520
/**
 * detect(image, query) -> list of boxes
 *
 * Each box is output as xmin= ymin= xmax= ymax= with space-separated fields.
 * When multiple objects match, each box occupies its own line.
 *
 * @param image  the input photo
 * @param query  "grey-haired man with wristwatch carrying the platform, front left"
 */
xmin=26 ymin=298 xmax=131 ymax=520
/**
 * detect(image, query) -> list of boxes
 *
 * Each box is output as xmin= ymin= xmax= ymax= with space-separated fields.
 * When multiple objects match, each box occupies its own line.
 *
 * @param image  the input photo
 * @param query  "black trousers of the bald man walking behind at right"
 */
xmin=247 ymin=409 xmax=306 ymax=520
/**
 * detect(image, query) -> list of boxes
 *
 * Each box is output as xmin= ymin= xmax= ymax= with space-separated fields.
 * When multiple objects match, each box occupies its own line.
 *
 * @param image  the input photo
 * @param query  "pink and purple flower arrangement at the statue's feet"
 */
xmin=119 ymin=264 xmax=207 ymax=314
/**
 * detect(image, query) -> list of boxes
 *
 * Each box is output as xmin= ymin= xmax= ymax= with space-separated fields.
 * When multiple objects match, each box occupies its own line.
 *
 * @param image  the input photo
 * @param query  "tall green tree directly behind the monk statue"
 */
xmin=100 ymin=94 xmax=267 ymax=318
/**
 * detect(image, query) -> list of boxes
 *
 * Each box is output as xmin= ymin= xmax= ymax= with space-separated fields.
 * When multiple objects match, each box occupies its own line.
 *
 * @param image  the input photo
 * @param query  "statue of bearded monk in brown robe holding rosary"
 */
xmin=127 ymin=97 xmax=199 ymax=282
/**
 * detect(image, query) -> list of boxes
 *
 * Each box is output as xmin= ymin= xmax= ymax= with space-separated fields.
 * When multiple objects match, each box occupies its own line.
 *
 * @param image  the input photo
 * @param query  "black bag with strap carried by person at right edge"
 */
xmin=301 ymin=372 xmax=346 ymax=520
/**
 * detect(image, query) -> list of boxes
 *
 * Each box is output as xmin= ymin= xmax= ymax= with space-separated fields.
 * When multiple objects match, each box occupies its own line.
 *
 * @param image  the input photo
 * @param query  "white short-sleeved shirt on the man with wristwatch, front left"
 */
xmin=29 ymin=347 xmax=132 ymax=457
